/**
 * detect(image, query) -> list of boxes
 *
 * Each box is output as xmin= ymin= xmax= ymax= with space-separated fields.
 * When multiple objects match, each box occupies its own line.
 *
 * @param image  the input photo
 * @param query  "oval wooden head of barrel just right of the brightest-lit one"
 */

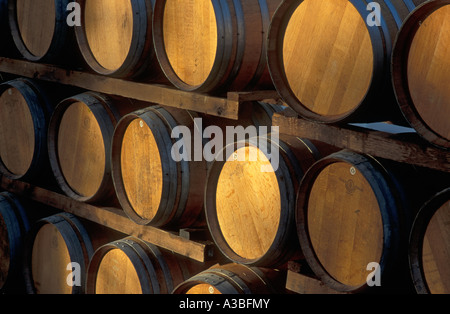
xmin=307 ymin=162 xmax=383 ymax=286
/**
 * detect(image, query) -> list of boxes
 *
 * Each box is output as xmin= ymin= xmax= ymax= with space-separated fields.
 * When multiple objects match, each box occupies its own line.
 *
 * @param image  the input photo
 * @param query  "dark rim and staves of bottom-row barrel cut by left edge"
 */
xmin=0 ymin=192 xmax=30 ymax=293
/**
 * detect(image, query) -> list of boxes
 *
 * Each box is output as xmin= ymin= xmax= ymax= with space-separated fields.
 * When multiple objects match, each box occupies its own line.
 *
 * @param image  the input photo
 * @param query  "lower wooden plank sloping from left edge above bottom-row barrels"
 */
xmin=0 ymin=175 xmax=213 ymax=262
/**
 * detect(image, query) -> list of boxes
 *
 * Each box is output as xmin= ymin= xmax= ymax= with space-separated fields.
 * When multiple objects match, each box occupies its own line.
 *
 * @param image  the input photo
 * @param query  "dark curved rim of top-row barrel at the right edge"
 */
xmin=391 ymin=0 xmax=450 ymax=150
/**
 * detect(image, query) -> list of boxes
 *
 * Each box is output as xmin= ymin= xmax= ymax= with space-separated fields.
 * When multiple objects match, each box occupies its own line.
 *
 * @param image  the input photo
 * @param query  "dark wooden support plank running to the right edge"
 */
xmin=273 ymin=109 xmax=450 ymax=172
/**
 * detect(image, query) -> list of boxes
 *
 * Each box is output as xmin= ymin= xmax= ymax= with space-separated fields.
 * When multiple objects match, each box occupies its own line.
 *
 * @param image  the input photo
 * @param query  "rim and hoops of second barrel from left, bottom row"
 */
xmin=23 ymin=213 xmax=94 ymax=294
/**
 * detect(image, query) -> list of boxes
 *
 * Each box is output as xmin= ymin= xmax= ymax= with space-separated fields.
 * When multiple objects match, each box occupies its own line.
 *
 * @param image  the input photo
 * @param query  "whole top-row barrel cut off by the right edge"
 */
xmin=392 ymin=1 xmax=450 ymax=149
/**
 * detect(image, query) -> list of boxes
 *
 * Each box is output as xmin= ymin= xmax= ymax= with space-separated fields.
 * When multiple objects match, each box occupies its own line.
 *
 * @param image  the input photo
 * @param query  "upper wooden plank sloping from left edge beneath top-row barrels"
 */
xmin=0 ymin=57 xmax=243 ymax=120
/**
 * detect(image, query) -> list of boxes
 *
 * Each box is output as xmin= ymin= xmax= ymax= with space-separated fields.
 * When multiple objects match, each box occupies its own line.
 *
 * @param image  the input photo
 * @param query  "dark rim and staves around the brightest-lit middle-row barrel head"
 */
xmin=205 ymin=138 xmax=320 ymax=267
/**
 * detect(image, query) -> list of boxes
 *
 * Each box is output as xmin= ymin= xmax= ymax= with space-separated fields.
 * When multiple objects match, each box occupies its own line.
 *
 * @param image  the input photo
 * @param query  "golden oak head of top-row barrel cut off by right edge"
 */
xmin=407 ymin=5 xmax=450 ymax=140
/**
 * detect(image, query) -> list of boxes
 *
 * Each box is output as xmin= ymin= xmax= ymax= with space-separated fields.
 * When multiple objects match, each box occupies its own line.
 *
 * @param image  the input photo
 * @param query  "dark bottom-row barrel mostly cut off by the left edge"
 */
xmin=0 ymin=192 xmax=30 ymax=293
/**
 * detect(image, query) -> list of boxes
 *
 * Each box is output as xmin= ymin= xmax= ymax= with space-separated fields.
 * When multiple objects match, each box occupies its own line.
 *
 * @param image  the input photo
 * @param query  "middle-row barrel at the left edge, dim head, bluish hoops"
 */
xmin=0 ymin=78 xmax=53 ymax=180
